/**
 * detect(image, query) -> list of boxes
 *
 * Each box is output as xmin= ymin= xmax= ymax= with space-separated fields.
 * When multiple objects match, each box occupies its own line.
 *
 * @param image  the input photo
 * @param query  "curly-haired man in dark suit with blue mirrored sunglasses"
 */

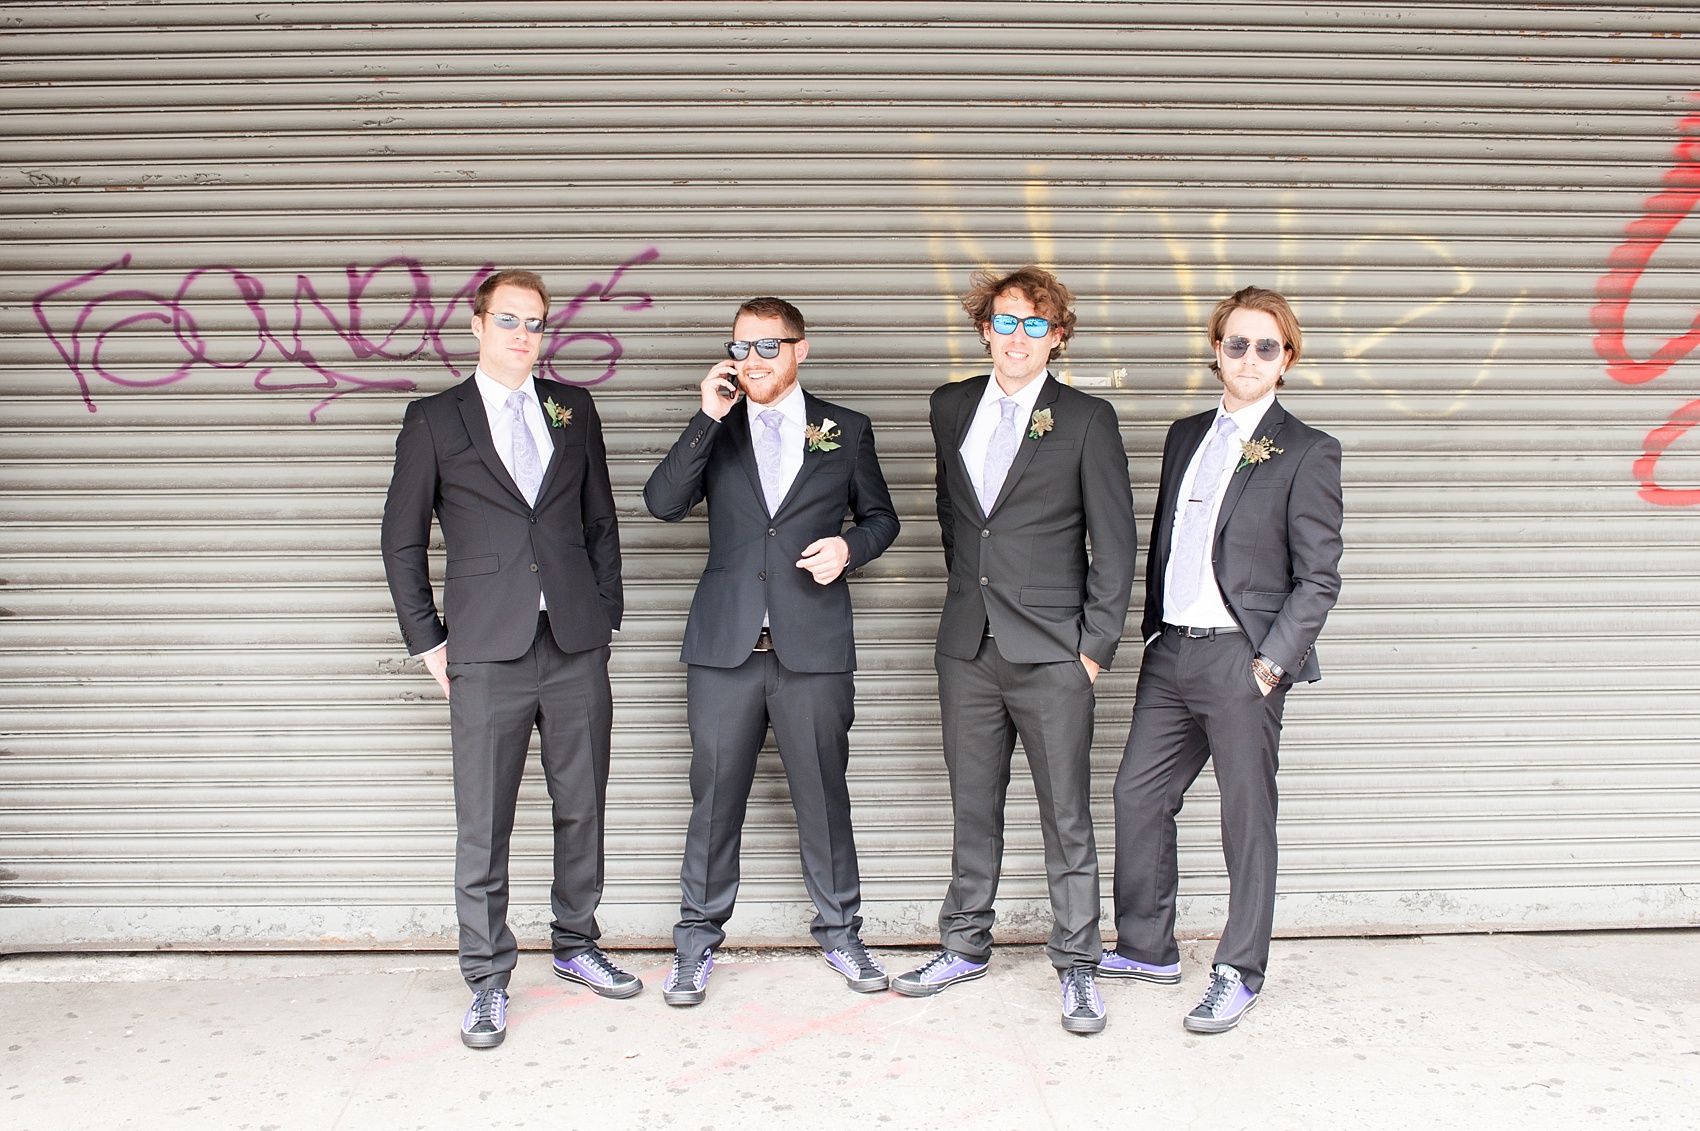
xmin=893 ymin=267 xmax=1137 ymax=1032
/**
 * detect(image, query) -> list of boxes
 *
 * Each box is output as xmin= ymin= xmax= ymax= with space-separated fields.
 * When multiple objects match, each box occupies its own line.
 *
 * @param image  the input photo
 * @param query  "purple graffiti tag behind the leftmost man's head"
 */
xmin=34 ymin=247 xmax=660 ymax=422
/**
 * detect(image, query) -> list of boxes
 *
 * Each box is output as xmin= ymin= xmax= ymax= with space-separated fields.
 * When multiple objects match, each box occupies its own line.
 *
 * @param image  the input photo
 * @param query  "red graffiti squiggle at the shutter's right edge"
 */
xmin=1591 ymin=102 xmax=1700 ymax=507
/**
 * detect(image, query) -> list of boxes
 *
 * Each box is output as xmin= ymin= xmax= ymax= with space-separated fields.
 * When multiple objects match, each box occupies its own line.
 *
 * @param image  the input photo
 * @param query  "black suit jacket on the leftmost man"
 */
xmin=383 ymin=378 xmax=626 ymax=662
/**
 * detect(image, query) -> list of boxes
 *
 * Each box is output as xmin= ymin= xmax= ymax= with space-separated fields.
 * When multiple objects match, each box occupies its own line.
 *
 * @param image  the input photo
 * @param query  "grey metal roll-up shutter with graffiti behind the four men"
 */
xmin=0 ymin=2 xmax=1700 ymax=951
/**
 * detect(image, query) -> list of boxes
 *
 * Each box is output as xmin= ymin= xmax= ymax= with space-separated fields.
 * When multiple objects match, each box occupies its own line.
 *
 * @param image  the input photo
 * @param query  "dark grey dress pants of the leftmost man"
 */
xmin=449 ymin=614 xmax=614 ymax=992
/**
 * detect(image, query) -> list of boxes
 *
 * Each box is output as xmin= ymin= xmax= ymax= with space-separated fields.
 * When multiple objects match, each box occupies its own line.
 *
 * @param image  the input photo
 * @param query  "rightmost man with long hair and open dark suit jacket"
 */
xmin=1098 ymin=287 xmax=1343 ymax=1032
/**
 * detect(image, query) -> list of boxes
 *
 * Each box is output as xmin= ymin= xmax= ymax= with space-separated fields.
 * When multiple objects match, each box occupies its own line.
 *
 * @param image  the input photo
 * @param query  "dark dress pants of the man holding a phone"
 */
xmin=673 ymin=651 xmax=862 ymax=954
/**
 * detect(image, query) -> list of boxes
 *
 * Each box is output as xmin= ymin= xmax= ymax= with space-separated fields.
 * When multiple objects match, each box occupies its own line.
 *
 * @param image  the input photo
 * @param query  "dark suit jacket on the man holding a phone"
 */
xmin=643 ymin=393 xmax=898 ymax=672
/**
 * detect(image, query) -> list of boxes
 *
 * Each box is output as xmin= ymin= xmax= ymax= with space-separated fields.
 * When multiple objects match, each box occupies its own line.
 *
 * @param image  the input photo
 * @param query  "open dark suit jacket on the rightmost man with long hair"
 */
xmin=1142 ymin=398 xmax=1345 ymax=682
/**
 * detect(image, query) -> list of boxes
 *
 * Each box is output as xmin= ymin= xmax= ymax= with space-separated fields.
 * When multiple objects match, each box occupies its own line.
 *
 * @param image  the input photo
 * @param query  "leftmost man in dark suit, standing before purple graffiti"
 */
xmin=383 ymin=270 xmax=643 ymax=1048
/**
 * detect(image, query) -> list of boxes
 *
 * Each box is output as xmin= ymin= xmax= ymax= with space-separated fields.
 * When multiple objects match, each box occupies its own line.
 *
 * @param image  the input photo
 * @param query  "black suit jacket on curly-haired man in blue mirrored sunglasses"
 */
xmin=932 ymin=374 xmax=1139 ymax=667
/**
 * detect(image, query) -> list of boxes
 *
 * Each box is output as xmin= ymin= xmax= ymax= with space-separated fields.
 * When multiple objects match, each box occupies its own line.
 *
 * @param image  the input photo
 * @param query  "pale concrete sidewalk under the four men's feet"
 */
xmin=0 ymin=930 xmax=1700 ymax=1131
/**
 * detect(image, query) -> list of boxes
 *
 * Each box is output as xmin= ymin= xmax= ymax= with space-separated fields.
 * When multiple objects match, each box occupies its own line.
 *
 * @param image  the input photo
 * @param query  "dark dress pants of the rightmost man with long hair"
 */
xmin=1115 ymin=629 xmax=1287 ymax=993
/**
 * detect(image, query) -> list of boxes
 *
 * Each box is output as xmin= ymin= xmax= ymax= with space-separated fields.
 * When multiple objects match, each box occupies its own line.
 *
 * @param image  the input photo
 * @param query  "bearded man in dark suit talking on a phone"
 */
xmin=643 ymin=298 xmax=898 ymax=1005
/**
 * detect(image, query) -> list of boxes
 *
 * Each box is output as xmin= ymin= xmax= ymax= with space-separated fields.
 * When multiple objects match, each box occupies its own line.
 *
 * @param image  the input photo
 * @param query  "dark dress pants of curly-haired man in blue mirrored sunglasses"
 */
xmin=935 ymin=636 xmax=1103 ymax=969
